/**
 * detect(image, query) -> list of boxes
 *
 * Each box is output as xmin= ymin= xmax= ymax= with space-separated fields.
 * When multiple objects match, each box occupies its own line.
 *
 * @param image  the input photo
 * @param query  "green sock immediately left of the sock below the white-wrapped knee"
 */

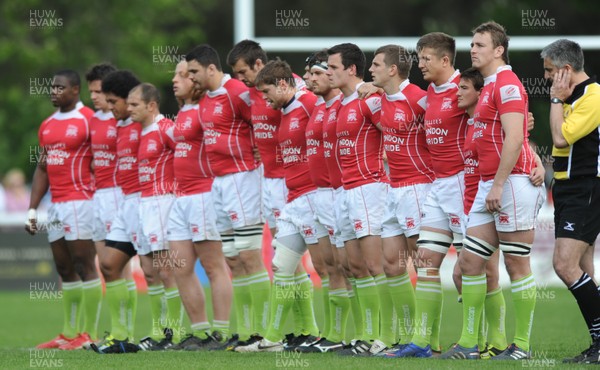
xmin=248 ymin=270 xmax=271 ymax=336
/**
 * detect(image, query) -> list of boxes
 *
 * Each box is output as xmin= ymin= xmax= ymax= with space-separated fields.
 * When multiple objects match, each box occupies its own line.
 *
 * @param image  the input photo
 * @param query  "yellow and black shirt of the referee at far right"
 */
xmin=552 ymin=76 xmax=600 ymax=180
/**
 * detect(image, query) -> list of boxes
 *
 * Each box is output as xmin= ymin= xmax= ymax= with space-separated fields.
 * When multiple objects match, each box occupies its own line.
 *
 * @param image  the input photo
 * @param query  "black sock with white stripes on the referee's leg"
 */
xmin=569 ymin=272 xmax=600 ymax=341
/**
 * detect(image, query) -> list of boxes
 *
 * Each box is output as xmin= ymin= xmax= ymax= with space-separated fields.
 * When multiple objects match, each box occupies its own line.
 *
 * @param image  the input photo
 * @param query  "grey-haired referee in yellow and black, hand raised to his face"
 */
xmin=541 ymin=39 xmax=600 ymax=363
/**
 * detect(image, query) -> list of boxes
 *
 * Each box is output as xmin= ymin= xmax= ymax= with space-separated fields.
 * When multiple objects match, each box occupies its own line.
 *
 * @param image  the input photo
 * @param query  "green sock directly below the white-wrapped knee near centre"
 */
xmin=265 ymin=272 xmax=296 ymax=342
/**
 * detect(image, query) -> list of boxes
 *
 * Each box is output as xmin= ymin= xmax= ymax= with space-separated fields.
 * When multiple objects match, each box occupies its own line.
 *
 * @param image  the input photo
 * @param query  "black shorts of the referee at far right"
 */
xmin=552 ymin=177 xmax=600 ymax=245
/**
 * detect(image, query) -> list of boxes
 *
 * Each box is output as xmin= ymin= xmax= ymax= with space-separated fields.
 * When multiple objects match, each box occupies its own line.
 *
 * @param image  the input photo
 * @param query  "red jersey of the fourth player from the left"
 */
xmin=138 ymin=114 xmax=177 ymax=197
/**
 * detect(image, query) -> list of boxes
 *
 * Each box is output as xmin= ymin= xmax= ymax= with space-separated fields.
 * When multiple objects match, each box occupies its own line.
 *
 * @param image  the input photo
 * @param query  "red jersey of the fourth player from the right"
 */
xmin=381 ymin=80 xmax=435 ymax=187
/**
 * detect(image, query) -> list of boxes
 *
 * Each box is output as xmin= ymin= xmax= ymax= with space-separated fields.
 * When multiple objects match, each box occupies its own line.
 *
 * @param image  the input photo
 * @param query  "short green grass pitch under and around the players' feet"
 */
xmin=0 ymin=287 xmax=589 ymax=370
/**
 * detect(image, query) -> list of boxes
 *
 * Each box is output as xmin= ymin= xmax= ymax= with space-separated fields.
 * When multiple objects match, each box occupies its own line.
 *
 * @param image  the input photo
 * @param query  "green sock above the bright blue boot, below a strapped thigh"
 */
xmin=412 ymin=280 xmax=442 ymax=347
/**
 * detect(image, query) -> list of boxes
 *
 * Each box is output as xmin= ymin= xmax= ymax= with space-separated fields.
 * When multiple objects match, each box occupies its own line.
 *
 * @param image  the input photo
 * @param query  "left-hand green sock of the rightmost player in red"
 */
xmin=458 ymin=274 xmax=487 ymax=348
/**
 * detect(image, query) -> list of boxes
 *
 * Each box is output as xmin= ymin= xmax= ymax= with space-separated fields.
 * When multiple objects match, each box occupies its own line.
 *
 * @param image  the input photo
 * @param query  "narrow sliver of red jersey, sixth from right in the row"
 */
xmin=323 ymin=94 xmax=342 ymax=189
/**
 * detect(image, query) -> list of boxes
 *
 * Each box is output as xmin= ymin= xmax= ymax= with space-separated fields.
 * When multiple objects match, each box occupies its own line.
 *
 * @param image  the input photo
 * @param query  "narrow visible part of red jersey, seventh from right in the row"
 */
xmin=306 ymin=97 xmax=331 ymax=188
